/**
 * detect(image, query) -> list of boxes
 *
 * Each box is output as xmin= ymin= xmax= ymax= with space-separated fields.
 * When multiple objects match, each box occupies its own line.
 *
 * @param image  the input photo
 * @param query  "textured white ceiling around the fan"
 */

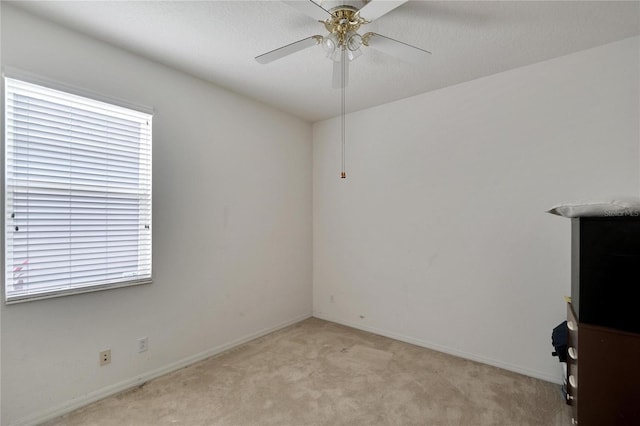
xmin=14 ymin=0 xmax=640 ymax=122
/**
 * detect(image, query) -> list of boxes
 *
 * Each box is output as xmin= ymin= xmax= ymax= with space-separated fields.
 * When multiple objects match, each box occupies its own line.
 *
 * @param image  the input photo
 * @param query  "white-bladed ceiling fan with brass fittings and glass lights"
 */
xmin=256 ymin=0 xmax=431 ymax=89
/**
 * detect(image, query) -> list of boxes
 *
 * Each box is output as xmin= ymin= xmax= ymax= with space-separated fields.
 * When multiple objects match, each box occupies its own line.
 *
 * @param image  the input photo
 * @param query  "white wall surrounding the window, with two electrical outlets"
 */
xmin=0 ymin=2 xmax=312 ymax=425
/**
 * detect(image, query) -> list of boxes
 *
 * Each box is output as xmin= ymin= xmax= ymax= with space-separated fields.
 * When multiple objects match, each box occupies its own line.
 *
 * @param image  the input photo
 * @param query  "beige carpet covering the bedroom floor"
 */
xmin=47 ymin=318 xmax=571 ymax=426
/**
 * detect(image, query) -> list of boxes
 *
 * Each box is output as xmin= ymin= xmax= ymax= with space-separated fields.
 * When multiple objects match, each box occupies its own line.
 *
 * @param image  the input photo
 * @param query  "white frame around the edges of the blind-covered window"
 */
xmin=0 ymin=68 xmax=153 ymax=305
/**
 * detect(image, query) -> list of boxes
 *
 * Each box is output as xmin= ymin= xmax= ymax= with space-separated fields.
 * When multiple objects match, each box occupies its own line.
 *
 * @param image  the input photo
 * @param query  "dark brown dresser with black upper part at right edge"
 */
xmin=567 ymin=216 xmax=640 ymax=426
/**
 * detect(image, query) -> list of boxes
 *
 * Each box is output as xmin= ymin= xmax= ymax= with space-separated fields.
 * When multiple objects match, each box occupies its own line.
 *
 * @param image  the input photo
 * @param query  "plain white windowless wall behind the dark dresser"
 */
xmin=313 ymin=38 xmax=640 ymax=382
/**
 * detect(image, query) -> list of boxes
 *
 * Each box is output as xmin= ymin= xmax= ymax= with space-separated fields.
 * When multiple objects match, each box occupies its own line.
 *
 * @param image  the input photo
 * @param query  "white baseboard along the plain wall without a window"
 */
xmin=313 ymin=311 xmax=562 ymax=384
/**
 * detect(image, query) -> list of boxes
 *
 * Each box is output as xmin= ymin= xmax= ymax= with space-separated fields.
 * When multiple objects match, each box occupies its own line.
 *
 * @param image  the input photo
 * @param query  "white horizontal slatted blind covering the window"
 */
xmin=5 ymin=78 xmax=152 ymax=303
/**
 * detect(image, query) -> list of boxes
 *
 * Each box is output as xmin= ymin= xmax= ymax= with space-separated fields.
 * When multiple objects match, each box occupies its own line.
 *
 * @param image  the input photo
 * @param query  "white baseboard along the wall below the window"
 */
xmin=12 ymin=314 xmax=312 ymax=426
